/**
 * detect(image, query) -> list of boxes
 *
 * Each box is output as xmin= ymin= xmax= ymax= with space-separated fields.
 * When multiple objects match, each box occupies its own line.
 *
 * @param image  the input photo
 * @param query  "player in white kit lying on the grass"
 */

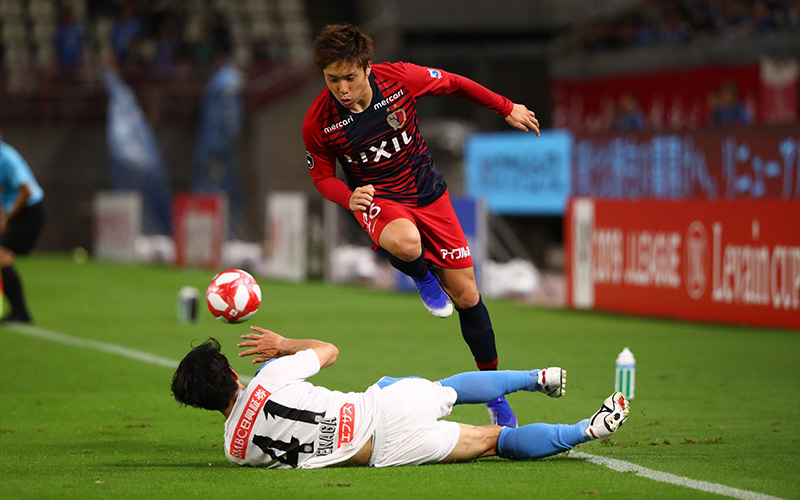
xmin=172 ymin=326 xmax=629 ymax=469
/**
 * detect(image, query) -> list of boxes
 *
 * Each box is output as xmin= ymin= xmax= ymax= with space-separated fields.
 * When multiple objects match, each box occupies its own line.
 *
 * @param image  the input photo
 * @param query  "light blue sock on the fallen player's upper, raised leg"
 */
xmin=439 ymin=370 xmax=542 ymax=405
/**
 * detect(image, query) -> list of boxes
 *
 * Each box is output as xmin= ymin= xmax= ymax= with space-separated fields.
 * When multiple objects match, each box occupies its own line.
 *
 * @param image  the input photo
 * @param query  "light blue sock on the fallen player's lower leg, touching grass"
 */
xmin=497 ymin=420 xmax=589 ymax=460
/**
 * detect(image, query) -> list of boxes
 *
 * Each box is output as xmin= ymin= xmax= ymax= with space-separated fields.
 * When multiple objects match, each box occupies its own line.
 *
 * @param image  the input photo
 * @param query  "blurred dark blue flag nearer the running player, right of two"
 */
xmin=192 ymin=63 xmax=244 ymax=237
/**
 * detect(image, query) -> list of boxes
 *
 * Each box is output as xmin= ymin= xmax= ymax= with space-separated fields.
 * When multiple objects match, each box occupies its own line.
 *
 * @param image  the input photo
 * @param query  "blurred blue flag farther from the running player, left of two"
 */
xmin=103 ymin=70 xmax=172 ymax=234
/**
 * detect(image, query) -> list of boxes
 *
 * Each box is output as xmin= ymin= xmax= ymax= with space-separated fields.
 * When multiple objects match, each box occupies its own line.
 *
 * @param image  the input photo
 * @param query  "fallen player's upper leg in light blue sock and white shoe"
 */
xmin=439 ymin=367 xmax=567 ymax=404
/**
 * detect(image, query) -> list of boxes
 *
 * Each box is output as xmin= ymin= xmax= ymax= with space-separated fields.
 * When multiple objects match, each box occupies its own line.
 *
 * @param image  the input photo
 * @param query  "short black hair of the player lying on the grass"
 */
xmin=172 ymin=337 xmax=239 ymax=411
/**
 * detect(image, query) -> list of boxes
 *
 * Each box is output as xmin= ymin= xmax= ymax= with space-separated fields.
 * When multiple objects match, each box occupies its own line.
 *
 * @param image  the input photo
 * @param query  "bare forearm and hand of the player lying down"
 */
xmin=236 ymin=326 xmax=339 ymax=369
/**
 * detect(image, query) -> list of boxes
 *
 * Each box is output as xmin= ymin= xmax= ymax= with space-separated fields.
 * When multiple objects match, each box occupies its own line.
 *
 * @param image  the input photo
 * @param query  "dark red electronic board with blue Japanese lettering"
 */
xmin=572 ymin=124 xmax=800 ymax=199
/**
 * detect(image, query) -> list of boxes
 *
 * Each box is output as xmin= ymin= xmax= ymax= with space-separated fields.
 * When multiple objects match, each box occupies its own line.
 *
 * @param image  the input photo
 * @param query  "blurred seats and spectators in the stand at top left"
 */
xmin=0 ymin=0 xmax=312 ymax=86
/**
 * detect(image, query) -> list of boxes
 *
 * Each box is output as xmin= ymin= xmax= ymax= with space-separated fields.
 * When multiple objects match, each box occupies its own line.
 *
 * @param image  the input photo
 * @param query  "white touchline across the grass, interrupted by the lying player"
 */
xmin=6 ymin=325 xmax=781 ymax=500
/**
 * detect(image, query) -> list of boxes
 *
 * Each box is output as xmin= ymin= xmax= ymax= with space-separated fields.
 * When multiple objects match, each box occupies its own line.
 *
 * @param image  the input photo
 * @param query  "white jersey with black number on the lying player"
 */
xmin=220 ymin=349 xmax=380 ymax=469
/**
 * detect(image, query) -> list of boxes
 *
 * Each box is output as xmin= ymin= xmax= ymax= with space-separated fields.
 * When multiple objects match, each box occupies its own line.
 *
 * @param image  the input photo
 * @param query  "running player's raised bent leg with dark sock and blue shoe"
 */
xmin=379 ymin=219 xmax=453 ymax=318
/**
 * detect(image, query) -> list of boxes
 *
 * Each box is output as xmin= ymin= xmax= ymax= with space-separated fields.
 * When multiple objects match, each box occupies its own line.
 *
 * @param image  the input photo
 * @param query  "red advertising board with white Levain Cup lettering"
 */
xmin=565 ymin=198 xmax=800 ymax=329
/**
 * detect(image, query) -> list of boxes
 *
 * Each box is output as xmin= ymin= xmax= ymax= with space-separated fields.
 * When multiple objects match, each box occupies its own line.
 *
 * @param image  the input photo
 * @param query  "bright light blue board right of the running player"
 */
xmin=464 ymin=130 xmax=573 ymax=215
